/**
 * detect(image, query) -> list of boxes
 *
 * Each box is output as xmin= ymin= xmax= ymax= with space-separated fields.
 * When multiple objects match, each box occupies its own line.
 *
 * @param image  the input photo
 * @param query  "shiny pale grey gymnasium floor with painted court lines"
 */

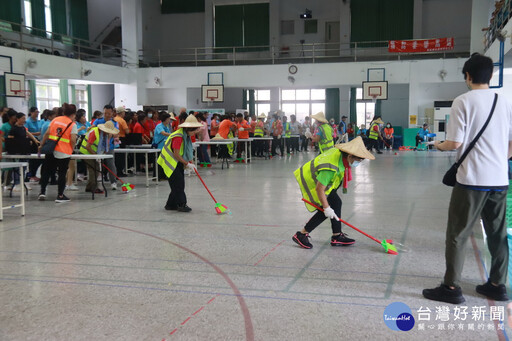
xmin=0 ymin=151 xmax=510 ymax=341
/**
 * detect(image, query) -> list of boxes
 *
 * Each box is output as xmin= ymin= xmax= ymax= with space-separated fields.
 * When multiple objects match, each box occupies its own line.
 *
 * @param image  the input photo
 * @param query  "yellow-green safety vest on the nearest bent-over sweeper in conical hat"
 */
xmin=293 ymin=148 xmax=345 ymax=212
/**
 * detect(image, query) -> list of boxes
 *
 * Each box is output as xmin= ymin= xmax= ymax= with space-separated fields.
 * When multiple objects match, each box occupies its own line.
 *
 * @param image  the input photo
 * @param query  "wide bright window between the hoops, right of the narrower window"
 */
xmin=281 ymin=89 xmax=325 ymax=122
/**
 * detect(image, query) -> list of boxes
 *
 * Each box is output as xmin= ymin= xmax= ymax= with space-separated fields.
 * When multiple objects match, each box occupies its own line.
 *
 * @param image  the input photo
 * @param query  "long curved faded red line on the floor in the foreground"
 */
xmin=66 ymin=217 xmax=254 ymax=341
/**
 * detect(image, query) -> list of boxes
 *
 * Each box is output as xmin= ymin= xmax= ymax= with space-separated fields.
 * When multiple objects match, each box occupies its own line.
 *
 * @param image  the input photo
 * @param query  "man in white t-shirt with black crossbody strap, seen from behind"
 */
xmin=423 ymin=53 xmax=512 ymax=304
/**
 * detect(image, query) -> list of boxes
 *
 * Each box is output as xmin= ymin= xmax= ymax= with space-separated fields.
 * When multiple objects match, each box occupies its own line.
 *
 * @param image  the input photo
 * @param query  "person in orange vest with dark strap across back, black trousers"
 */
xmin=38 ymin=103 xmax=78 ymax=203
